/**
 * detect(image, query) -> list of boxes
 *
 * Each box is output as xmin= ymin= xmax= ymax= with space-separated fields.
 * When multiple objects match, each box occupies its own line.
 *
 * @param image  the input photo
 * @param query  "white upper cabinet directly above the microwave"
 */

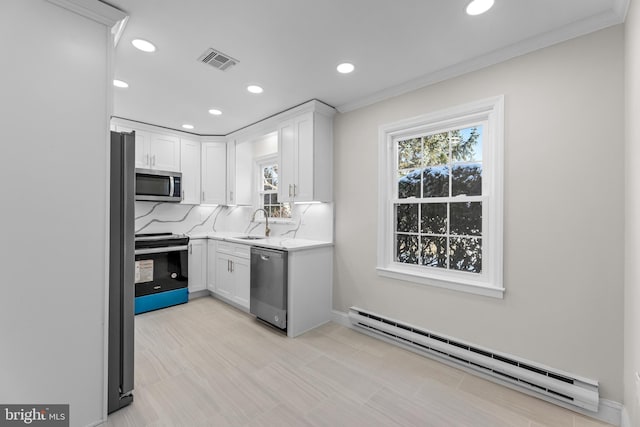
xmin=116 ymin=125 xmax=180 ymax=172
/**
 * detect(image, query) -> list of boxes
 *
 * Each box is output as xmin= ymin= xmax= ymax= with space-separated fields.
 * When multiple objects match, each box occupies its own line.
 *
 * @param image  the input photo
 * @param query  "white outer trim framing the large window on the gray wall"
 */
xmin=377 ymin=95 xmax=505 ymax=298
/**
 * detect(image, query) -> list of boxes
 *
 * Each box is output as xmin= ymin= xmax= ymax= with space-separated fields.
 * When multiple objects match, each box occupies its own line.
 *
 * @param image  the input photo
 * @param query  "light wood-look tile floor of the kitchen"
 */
xmin=105 ymin=297 xmax=608 ymax=427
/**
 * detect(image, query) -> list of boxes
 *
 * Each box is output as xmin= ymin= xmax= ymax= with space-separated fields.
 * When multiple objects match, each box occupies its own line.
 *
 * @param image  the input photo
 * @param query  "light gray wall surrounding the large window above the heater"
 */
xmin=334 ymin=26 xmax=624 ymax=402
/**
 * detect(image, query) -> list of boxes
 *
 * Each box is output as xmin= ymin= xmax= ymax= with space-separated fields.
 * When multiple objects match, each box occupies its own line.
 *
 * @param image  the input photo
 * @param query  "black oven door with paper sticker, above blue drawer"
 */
xmin=135 ymin=246 xmax=189 ymax=297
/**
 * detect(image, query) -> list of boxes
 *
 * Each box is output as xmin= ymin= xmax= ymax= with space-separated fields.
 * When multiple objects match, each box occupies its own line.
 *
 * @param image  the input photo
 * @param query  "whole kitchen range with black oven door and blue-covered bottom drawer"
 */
xmin=135 ymin=233 xmax=189 ymax=314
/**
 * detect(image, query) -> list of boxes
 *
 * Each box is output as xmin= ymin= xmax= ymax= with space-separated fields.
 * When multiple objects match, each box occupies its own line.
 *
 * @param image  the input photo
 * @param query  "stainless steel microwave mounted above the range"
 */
xmin=136 ymin=169 xmax=182 ymax=202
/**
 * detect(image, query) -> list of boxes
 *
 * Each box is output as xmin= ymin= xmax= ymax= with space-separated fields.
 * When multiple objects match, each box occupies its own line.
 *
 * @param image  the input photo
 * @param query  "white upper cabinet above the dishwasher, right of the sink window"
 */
xmin=278 ymin=111 xmax=333 ymax=202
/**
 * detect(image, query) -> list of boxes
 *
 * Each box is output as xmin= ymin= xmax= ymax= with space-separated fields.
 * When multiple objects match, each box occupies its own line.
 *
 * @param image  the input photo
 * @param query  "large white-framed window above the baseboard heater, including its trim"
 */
xmin=377 ymin=96 xmax=504 ymax=298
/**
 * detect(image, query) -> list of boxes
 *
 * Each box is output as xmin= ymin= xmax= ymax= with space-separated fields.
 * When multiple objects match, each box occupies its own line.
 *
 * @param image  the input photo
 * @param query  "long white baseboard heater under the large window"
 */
xmin=349 ymin=307 xmax=599 ymax=412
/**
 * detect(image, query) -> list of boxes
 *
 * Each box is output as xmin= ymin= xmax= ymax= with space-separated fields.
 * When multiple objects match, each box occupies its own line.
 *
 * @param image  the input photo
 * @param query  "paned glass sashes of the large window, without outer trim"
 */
xmin=393 ymin=125 xmax=485 ymax=273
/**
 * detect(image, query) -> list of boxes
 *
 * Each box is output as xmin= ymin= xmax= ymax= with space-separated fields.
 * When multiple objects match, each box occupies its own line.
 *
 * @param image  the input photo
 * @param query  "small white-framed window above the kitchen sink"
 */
xmin=256 ymin=154 xmax=291 ymax=222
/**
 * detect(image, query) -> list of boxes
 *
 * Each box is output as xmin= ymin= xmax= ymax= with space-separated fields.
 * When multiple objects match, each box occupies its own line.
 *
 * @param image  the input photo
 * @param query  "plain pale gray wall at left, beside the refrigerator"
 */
xmin=0 ymin=0 xmax=110 ymax=426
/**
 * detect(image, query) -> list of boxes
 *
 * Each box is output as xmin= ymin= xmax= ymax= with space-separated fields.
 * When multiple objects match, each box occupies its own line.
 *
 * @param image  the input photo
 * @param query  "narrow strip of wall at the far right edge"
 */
xmin=624 ymin=0 xmax=640 ymax=426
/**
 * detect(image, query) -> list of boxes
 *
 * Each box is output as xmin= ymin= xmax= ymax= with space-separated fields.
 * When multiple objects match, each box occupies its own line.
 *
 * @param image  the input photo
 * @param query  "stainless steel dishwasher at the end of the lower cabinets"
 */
xmin=249 ymin=246 xmax=288 ymax=331
